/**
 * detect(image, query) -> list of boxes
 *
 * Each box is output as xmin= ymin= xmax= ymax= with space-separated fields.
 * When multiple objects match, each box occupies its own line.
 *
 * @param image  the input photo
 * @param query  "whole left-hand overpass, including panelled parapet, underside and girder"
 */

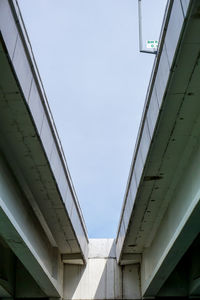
xmin=0 ymin=0 xmax=88 ymax=298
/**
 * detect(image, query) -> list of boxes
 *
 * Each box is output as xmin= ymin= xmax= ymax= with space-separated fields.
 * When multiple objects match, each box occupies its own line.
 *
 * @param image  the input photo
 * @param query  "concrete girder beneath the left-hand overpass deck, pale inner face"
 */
xmin=0 ymin=155 xmax=62 ymax=297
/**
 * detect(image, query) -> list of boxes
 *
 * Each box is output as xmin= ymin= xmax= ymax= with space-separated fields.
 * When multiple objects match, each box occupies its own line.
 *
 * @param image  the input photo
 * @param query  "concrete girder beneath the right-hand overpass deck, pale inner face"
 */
xmin=141 ymin=125 xmax=200 ymax=297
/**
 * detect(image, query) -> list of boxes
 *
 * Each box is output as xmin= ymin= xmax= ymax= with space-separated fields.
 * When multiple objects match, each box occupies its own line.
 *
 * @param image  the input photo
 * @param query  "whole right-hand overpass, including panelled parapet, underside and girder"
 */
xmin=117 ymin=0 xmax=200 ymax=298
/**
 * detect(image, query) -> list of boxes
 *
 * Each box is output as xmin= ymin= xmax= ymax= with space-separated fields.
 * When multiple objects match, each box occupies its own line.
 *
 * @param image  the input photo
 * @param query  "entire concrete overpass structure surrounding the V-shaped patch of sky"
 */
xmin=0 ymin=0 xmax=200 ymax=300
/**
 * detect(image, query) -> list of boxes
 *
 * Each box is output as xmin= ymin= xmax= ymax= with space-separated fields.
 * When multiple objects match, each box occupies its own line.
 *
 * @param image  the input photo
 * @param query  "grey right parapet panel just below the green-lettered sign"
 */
xmin=155 ymin=44 xmax=170 ymax=107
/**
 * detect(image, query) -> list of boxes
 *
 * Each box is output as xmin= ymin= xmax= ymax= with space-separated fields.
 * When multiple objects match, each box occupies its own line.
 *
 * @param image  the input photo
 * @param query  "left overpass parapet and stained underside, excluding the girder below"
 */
xmin=0 ymin=0 xmax=88 ymax=262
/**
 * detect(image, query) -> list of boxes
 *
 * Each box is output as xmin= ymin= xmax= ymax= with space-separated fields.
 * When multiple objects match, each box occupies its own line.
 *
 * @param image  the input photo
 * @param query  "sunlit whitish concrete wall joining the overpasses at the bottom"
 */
xmin=63 ymin=239 xmax=141 ymax=300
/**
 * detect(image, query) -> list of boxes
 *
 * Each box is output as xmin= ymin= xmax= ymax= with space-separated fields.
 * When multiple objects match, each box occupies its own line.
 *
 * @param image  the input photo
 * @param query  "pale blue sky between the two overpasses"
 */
xmin=18 ymin=0 xmax=166 ymax=238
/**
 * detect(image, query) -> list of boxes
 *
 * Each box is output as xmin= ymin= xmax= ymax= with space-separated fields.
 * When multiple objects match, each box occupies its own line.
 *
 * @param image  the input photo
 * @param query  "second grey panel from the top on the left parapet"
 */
xmin=12 ymin=36 xmax=33 ymax=101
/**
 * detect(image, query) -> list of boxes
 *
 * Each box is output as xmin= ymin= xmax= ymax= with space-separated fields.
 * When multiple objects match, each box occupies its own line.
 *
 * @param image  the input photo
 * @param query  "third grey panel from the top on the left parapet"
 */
xmin=28 ymin=80 xmax=44 ymax=135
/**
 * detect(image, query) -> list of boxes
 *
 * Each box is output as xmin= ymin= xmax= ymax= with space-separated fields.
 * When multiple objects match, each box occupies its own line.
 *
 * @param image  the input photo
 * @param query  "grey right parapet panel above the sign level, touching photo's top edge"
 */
xmin=165 ymin=0 xmax=184 ymax=67
